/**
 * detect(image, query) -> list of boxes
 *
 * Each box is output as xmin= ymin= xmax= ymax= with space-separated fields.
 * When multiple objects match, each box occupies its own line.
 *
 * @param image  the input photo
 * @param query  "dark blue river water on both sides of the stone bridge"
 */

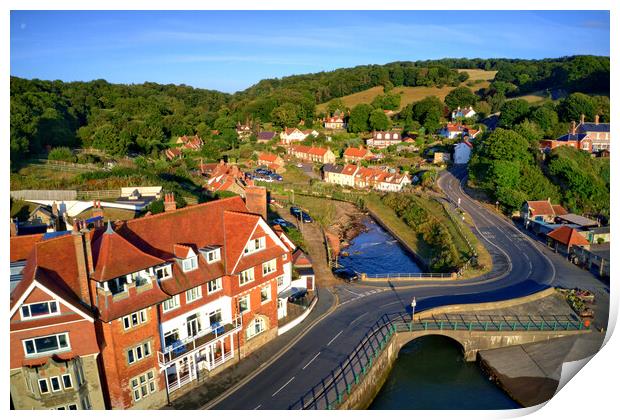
xmin=340 ymin=218 xmax=520 ymax=410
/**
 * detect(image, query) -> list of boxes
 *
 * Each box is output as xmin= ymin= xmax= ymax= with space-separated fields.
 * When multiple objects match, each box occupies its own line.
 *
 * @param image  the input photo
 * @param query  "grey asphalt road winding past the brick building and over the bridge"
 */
xmin=212 ymin=168 xmax=598 ymax=409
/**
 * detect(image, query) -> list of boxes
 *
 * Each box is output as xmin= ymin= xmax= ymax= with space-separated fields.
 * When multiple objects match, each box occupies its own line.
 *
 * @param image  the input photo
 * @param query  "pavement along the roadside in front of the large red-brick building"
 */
xmin=164 ymin=287 xmax=337 ymax=410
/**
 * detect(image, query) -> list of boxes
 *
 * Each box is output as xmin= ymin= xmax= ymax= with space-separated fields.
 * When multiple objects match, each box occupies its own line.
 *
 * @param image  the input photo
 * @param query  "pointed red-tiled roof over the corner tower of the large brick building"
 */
xmin=91 ymin=225 xmax=164 ymax=281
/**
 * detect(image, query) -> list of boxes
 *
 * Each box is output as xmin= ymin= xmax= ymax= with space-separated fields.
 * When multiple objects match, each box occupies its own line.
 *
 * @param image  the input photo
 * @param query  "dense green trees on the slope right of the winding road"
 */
xmin=469 ymin=124 xmax=610 ymax=217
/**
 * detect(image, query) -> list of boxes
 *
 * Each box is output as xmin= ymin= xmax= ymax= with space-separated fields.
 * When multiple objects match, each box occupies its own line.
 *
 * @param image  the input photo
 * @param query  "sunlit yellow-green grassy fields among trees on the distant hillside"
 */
xmin=316 ymin=69 xmax=497 ymax=112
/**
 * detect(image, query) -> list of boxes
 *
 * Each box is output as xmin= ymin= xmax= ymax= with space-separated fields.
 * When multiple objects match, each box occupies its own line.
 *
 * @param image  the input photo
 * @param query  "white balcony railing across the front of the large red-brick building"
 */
xmin=157 ymin=315 xmax=242 ymax=367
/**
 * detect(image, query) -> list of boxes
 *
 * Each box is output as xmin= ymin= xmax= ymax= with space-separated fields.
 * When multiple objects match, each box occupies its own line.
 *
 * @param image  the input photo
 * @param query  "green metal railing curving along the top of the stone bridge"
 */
xmin=289 ymin=312 xmax=588 ymax=410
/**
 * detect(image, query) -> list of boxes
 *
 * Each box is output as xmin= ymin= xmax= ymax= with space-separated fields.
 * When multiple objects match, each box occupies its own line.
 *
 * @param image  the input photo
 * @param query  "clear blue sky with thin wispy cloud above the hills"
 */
xmin=11 ymin=11 xmax=610 ymax=92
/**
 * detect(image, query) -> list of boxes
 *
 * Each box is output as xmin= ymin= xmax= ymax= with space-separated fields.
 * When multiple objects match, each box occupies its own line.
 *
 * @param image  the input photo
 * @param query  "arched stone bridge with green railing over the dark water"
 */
xmin=290 ymin=313 xmax=590 ymax=409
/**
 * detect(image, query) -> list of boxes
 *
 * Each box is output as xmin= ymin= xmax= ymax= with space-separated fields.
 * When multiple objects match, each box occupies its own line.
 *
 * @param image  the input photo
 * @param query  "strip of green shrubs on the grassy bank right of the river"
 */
xmin=381 ymin=193 xmax=460 ymax=272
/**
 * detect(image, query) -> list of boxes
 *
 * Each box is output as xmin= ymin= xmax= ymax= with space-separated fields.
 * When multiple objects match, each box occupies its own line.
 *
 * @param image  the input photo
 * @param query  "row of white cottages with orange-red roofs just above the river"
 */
xmin=322 ymin=164 xmax=411 ymax=192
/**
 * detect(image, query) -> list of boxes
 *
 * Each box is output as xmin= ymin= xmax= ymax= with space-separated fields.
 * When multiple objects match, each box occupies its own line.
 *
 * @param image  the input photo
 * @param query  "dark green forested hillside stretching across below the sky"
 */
xmin=10 ymin=56 xmax=609 ymax=167
